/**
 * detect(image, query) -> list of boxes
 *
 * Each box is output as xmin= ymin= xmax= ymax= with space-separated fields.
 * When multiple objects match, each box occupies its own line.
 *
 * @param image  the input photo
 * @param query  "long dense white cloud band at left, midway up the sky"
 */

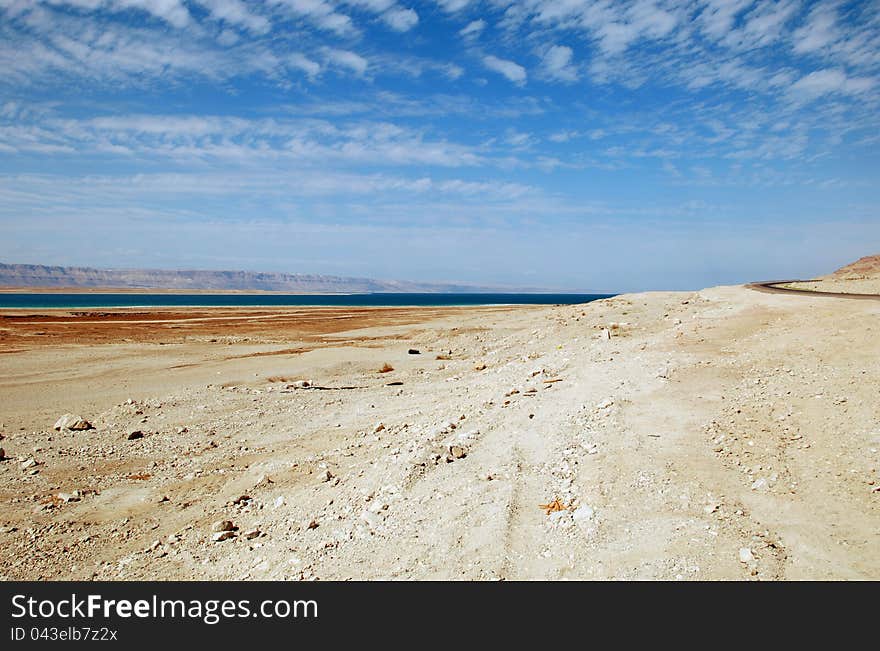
xmin=0 ymin=107 xmax=491 ymax=168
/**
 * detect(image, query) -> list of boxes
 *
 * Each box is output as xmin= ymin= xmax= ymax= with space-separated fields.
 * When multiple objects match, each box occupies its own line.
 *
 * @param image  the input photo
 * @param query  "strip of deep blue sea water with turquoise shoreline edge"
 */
xmin=0 ymin=293 xmax=613 ymax=309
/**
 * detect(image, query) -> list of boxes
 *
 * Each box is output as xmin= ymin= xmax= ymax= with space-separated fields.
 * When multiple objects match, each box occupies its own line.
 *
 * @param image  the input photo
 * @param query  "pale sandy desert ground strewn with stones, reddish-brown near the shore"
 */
xmin=0 ymin=280 xmax=880 ymax=580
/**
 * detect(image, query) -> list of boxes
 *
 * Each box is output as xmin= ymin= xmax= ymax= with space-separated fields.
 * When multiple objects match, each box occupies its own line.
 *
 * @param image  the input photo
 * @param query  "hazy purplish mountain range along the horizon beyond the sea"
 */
xmin=0 ymin=263 xmax=524 ymax=294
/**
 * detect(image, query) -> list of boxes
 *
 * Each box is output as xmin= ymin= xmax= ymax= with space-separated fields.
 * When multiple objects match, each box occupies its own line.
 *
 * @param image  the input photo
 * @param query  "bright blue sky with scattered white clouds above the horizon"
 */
xmin=0 ymin=0 xmax=880 ymax=291
